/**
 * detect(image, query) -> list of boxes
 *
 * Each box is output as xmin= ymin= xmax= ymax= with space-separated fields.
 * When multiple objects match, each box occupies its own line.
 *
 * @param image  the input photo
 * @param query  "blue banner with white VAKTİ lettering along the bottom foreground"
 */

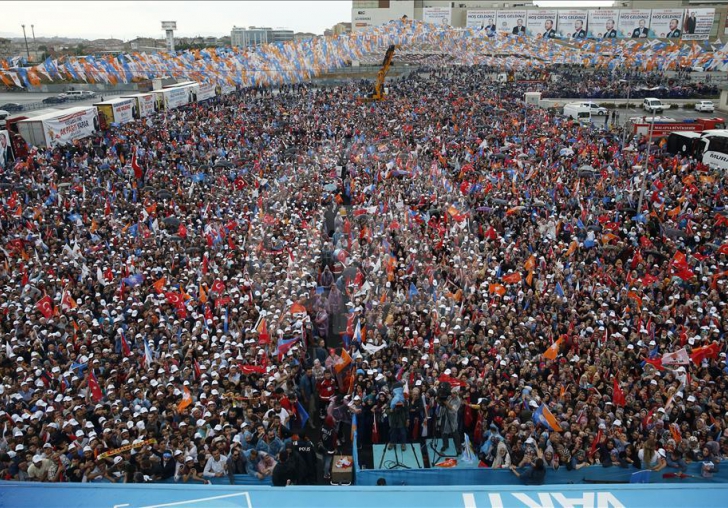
xmin=0 ymin=482 xmax=728 ymax=508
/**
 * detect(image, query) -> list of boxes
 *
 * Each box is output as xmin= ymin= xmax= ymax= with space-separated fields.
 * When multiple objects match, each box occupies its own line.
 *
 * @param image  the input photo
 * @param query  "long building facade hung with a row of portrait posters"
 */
xmin=351 ymin=0 xmax=728 ymax=40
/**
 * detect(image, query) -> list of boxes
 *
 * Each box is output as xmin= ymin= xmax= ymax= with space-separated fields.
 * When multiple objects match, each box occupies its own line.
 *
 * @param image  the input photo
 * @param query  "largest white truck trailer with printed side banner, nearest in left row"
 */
xmin=17 ymin=106 xmax=99 ymax=147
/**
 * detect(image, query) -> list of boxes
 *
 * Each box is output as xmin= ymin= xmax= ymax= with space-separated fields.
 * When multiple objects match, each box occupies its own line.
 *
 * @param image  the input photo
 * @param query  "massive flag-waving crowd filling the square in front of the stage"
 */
xmin=0 ymin=67 xmax=728 ymax=484
